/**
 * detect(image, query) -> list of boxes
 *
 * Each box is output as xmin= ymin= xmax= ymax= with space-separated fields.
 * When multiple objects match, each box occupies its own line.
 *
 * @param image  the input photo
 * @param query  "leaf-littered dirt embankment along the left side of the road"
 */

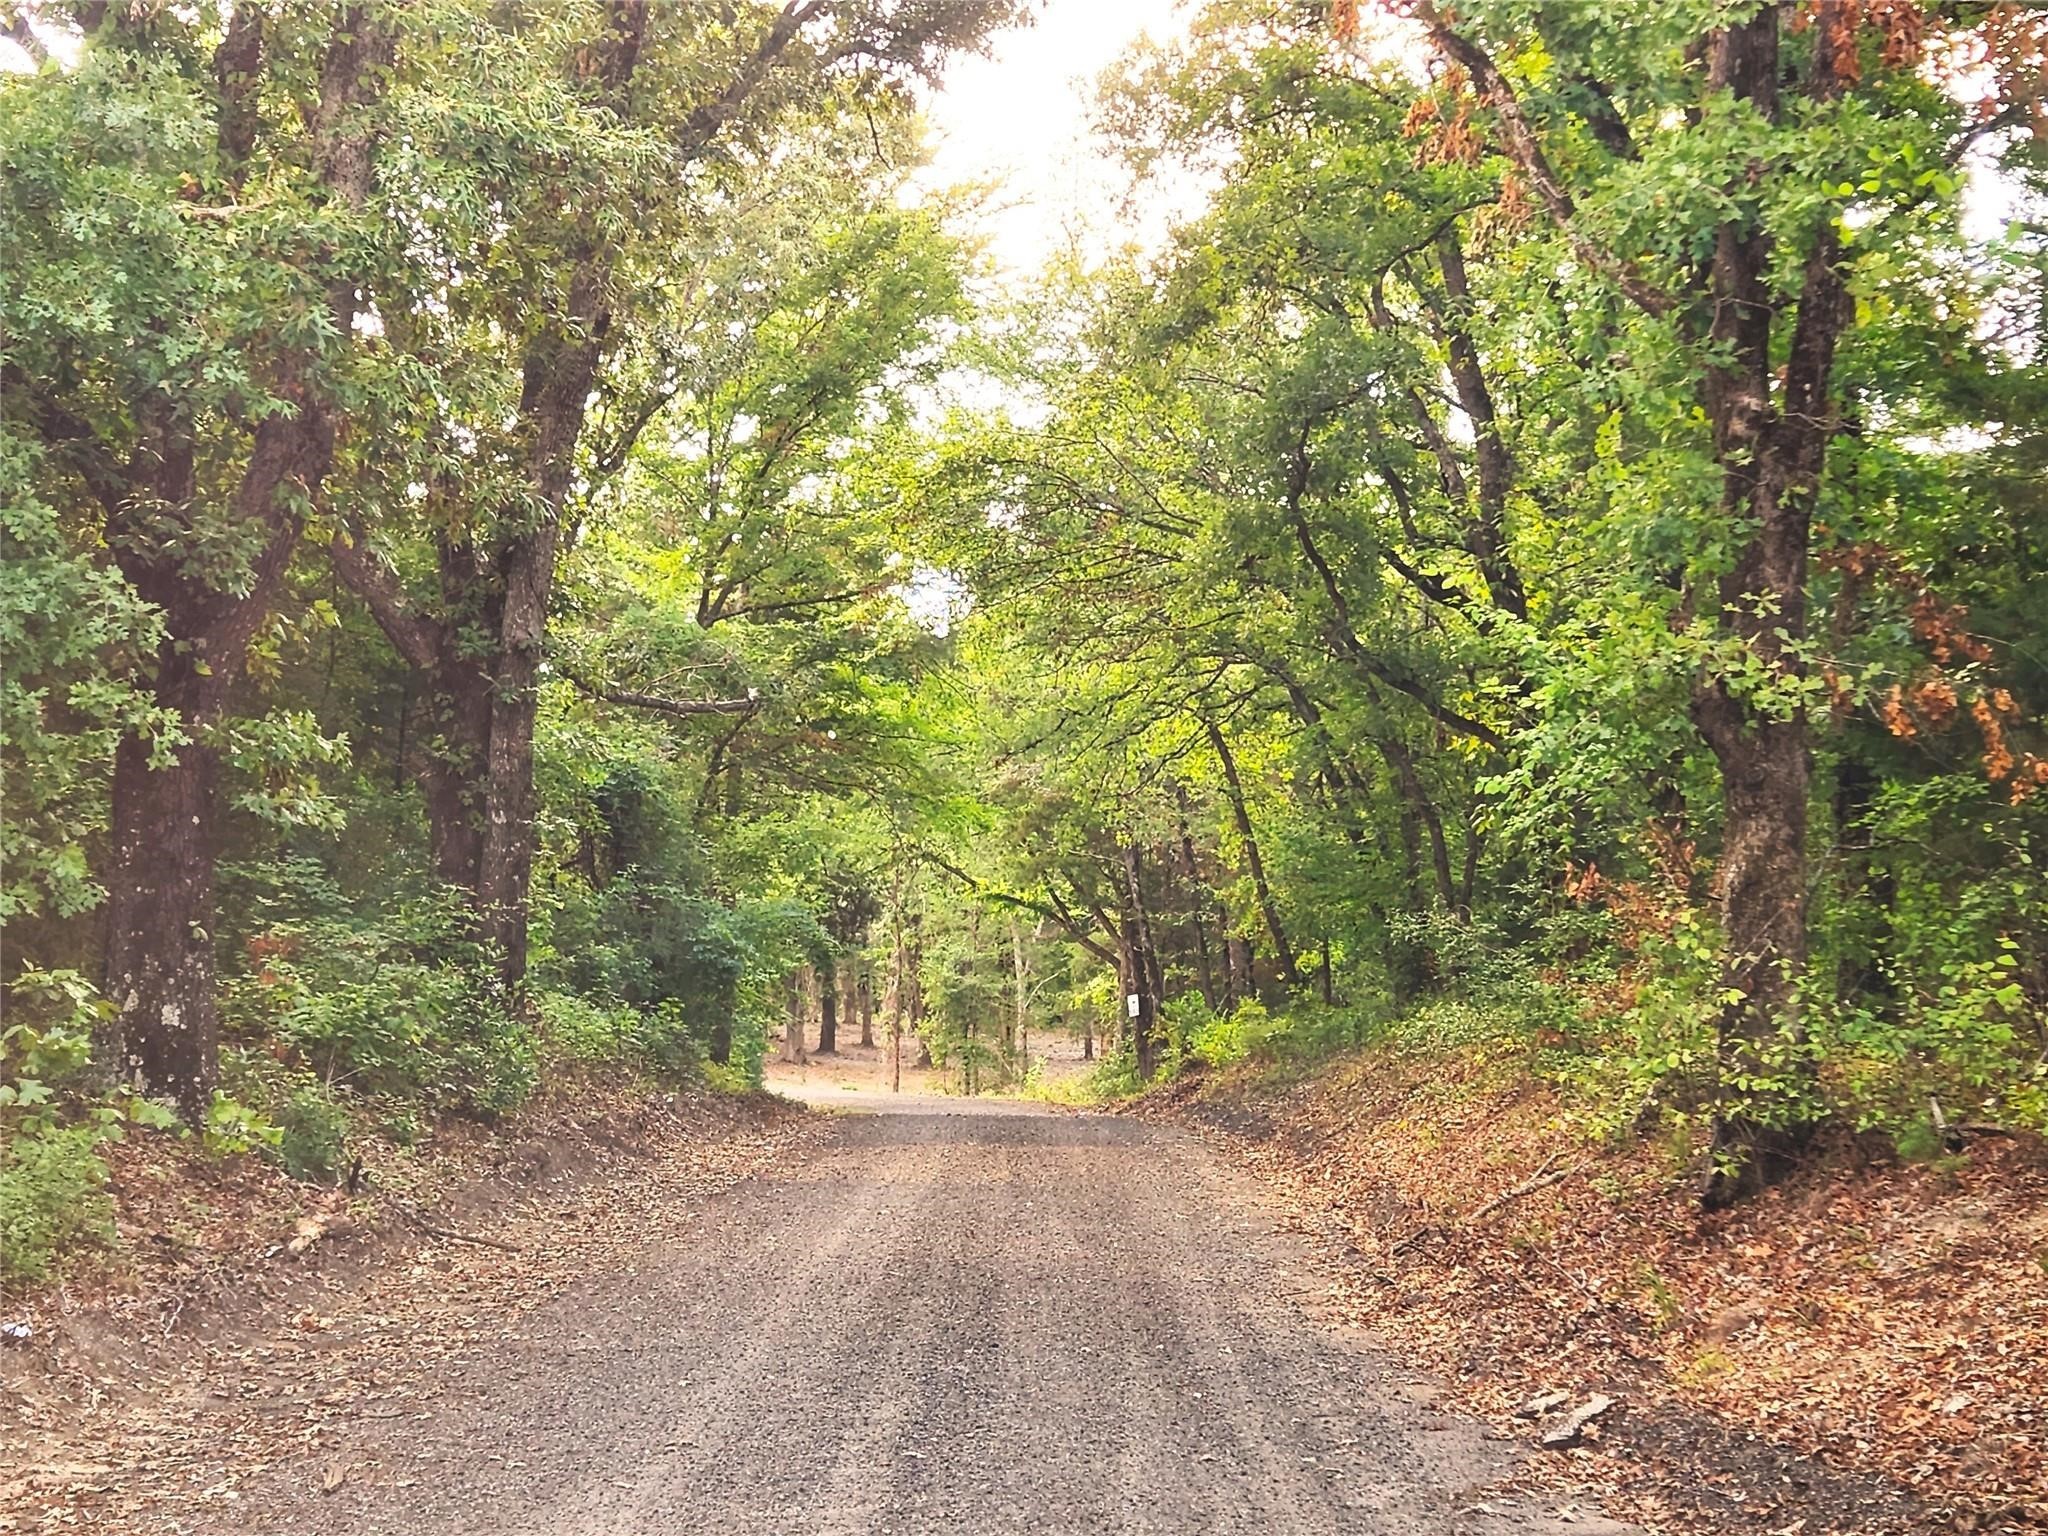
xmin=0 ymin=1079 xmax=815 ymax=1532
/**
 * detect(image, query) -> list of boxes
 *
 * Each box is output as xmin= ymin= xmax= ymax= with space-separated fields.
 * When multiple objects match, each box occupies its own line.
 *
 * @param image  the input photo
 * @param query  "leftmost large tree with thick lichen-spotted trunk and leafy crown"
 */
xmin=0 ymin=6 xmax=397 ymax=1116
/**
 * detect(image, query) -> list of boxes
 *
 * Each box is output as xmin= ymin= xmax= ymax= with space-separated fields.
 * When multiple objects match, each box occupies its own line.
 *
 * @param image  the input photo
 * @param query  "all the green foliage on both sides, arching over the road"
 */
xmin=0 ymin=0 xmax=2048 ymax=1302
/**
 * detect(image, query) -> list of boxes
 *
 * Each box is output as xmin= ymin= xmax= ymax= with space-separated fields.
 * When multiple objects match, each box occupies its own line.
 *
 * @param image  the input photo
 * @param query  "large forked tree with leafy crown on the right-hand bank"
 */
xmin=1415 ymin=0 xmax=2031 ymax=1204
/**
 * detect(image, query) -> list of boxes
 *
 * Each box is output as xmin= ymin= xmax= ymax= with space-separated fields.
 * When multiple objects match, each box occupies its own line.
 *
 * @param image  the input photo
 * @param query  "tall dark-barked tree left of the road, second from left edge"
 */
xmin=330 ymin=0 xmax=1012 ymax=989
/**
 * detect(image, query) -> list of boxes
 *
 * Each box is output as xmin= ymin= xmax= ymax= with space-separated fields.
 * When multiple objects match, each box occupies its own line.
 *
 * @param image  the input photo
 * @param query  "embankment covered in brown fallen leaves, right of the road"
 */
xmin=1139 ymin=1053 xmax=2048 ymax=1536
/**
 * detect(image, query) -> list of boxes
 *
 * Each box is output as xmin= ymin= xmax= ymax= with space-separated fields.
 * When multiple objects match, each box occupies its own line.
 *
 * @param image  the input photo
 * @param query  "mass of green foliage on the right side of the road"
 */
xmin=905 ymin=4 xmax=2048 ymax=1179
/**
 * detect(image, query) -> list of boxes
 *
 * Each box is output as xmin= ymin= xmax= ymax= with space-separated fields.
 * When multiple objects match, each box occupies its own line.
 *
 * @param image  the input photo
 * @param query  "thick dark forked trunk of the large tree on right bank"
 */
xmin=1415 ymin=0 xmax=1860 ymax=1208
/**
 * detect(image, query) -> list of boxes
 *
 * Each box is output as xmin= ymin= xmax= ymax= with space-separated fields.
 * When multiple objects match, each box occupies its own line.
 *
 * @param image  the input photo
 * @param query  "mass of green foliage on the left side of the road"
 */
xmin=0 ymin=0 xmax=1016 ymax=1277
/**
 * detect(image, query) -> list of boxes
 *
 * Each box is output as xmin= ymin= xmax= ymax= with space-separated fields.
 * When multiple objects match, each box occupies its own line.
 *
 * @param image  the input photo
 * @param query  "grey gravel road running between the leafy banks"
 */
xmin=195 ymin=1094 xmax=1622 ymax=1536
